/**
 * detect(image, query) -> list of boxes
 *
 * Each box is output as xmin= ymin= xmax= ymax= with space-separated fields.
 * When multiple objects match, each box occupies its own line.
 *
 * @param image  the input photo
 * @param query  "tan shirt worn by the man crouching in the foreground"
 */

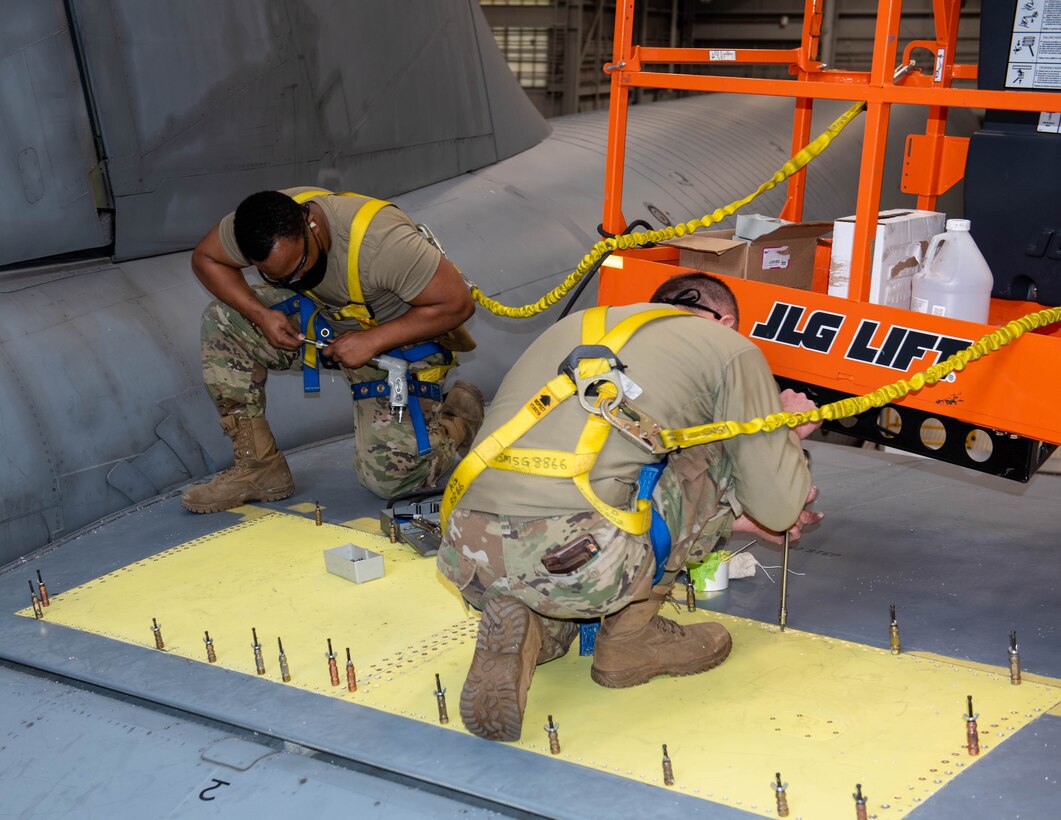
xmin=459 ymin=304 xmax=811 ymax=530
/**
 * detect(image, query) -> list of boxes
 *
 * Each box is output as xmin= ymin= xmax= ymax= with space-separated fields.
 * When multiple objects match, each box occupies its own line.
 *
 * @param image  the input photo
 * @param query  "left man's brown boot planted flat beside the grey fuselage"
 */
xmin=180 ymin=416 xmax=295 ymax=512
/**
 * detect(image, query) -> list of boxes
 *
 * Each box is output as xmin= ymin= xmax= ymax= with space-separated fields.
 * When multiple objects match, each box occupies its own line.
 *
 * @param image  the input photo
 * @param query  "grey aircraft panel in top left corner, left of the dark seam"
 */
xmin=0 ymin=0 xmax=109 ymax=266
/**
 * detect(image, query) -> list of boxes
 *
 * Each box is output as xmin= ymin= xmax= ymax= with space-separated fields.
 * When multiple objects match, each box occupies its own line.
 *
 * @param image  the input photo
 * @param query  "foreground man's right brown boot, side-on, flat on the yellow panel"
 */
xmin=590 ymin=591 xmax=733 ymax=688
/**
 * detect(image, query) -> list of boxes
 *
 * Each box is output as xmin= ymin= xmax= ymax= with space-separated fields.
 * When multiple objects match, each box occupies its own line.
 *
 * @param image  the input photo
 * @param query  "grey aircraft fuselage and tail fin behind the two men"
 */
xmin=0 ymin=0 xmax=971 ymax=566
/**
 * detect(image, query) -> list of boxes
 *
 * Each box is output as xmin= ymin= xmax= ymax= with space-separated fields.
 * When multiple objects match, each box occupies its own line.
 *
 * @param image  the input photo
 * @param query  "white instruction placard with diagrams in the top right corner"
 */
xmin=1006 ymin=0 xmax=1061 ymax=89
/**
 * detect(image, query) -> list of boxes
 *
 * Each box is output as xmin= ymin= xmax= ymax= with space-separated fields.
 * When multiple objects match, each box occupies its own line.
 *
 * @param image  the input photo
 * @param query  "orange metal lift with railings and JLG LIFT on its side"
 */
xmin=598 ymin=0 xmax=1061 ymax=481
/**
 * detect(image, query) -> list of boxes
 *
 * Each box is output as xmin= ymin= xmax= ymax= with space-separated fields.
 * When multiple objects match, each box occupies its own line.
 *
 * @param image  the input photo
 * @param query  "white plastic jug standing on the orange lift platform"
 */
xmin=910 ymin=220 xmax=994 ymax=325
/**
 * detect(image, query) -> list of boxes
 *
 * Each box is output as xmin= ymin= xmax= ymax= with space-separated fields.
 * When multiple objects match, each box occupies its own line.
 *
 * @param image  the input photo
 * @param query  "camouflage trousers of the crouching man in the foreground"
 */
xmin=438 ymin=444 xmax=733 ymax=628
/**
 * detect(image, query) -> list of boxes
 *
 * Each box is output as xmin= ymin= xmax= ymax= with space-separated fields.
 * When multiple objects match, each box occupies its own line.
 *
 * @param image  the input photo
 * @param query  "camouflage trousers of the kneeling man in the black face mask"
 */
xmin=201 ymin=284 xmax=456 ymax=498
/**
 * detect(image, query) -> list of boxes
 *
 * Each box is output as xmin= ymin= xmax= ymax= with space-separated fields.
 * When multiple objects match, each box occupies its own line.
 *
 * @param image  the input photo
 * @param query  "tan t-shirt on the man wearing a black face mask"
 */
xmin=218 ymin=187 xmax=441 ymax=329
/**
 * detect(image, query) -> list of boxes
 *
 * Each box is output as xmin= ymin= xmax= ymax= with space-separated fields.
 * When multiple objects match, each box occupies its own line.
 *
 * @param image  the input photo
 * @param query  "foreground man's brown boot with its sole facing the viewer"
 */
xmin=460 ymin=596 xmax=542 ymax=740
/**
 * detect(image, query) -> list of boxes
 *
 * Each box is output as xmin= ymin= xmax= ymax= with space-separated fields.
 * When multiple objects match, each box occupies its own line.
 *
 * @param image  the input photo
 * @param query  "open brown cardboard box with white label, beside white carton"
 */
xmin=667 ymin=222 xmax=833 ymax=291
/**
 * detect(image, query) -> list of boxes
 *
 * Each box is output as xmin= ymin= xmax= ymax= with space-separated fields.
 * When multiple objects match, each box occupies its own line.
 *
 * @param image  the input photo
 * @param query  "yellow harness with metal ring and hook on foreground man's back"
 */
xmin=440 ymin=306 xmax=693 ymax=528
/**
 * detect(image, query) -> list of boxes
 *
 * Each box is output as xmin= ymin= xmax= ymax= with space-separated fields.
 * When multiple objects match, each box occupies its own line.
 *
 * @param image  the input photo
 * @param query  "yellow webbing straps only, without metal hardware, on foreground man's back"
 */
xmin=439 ymin=306 xmax=693 ymax=535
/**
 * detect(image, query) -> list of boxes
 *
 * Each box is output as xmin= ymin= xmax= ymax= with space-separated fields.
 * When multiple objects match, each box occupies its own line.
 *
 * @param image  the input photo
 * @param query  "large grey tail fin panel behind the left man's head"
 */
xmin=72 ymin=0 xmax=549 ymax=259
